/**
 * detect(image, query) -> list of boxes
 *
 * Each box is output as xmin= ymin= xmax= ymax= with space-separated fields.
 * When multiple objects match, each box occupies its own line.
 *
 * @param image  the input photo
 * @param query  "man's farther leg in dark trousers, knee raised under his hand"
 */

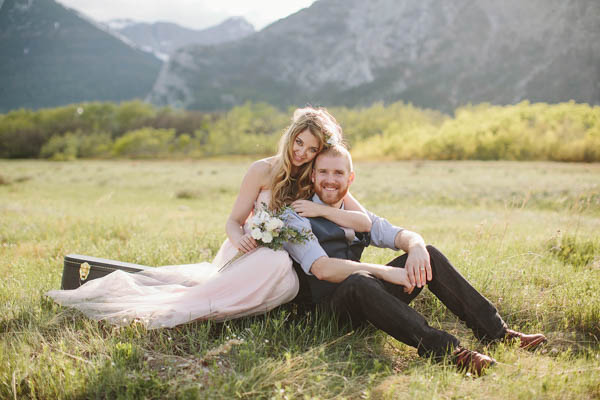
xmin=384 ymin=245 xmax=507 ymax=341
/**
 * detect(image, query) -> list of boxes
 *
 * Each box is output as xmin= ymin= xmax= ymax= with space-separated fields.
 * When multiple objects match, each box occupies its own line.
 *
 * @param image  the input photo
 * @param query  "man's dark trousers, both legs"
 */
xmin=324 ymin=246 xmax=506 ymax=358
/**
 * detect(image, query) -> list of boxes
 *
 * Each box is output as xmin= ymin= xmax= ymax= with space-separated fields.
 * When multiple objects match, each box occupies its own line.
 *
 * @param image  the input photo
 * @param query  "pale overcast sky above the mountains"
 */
xmin=58 ymin=0 xmax=315 ymax=30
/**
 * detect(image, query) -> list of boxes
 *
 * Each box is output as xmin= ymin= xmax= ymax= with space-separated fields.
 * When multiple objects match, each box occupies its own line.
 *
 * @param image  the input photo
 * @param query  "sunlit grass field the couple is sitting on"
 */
xmin=0 ymin=159 xmax=600 ymax=399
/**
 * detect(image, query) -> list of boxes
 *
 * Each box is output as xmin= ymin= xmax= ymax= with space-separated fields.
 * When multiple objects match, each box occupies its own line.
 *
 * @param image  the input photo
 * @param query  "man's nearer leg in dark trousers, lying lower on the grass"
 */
xmin=329 ymin=271 xmax=459 ymax=358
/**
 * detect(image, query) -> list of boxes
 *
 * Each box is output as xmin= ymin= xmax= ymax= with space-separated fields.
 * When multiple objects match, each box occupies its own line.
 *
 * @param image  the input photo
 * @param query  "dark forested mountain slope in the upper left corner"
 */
xmin=0 ymin=0 xmax=162 ymax=112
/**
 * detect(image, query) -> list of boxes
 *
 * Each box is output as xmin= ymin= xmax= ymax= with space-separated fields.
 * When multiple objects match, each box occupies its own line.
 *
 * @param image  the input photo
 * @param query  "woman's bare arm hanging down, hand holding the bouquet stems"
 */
xmin=225 ymin=160 xmax=270 ymax=253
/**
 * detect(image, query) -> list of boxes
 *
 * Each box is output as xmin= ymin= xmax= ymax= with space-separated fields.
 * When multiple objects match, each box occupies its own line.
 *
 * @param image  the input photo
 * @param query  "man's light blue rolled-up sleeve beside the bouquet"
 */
xmin=282 ymin=210 xmax=327 ymax=275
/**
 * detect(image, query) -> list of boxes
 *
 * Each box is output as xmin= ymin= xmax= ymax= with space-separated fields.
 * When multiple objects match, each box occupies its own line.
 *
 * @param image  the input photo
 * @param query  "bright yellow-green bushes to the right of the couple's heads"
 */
xmin=354 ymin=101 xmax=600 ymax=162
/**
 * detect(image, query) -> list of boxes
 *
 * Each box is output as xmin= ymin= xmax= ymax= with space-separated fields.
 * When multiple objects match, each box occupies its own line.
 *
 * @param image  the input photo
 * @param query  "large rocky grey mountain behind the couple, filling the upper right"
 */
xmin=148 ymin=0 xmax=600 ymax=112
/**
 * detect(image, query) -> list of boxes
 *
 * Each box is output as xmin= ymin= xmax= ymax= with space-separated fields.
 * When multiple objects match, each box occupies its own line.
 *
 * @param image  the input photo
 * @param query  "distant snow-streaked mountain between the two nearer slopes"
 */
xmin=108 ymin=17 xmax=254 ymax=60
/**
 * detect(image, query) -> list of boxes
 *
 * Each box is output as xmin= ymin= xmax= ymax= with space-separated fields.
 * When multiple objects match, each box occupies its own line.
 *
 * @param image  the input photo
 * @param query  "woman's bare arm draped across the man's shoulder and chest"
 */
xmin=292 ymin=193 xmax=371 ymax=232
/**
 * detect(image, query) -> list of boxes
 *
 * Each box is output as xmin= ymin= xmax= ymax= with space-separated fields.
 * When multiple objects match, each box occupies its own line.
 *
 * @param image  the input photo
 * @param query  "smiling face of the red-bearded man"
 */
xmin=312 ymin=154 xmax=354 ymax=207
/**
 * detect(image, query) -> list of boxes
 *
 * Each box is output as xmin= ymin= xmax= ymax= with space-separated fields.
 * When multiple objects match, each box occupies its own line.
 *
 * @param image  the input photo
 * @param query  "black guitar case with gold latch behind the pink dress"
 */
xmin=61 ymin=254 xmax=152 ymax=289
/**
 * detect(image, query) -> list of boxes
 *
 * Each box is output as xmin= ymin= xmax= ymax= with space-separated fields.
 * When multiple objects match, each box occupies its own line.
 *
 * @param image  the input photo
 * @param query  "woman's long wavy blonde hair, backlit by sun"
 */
xmin=270 ymin=107 xmax=343 ymax=210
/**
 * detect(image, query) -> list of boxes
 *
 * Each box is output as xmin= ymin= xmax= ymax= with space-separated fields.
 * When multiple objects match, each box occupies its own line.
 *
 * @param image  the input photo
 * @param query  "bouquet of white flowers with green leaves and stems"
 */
xmin=219 ymin=203 xmax=314 ymax=272
